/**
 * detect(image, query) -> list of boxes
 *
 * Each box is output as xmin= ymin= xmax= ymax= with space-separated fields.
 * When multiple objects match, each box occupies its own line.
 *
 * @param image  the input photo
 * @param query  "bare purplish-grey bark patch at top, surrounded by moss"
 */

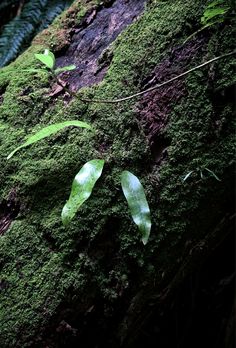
xmin=57 ymin=0 xmax=146 ymax=90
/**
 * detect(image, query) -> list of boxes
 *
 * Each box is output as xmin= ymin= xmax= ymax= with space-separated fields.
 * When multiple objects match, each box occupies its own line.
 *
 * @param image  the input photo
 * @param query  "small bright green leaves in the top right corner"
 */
xmin=201 ymin=0 xmax=230 ymax=26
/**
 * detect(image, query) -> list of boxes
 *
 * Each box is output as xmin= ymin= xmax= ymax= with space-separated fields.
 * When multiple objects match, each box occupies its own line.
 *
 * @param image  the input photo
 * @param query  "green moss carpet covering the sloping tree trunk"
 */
xmin=0 ymin=0 xmax=235 ymax=348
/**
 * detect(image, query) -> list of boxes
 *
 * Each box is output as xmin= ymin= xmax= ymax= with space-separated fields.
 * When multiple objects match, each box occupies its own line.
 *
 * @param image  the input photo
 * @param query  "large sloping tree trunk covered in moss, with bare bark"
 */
xmin=0 ymin=0 xmax=235 ymax=348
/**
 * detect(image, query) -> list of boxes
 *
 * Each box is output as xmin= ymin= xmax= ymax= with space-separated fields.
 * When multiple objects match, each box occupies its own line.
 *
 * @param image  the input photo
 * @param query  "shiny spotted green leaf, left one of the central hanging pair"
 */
xmin=61 ymin=159 xmax=104 ymax=226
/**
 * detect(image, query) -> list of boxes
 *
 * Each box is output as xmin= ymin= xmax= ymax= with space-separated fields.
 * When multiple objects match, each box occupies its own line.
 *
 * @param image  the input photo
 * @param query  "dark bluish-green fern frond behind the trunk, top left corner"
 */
xmin=0 ymin=0 xmax=72 ymax=67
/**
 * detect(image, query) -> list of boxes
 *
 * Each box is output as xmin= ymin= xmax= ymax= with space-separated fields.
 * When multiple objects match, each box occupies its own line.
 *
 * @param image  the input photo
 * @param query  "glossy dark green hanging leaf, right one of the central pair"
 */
xmin=121 ymin=170 xmax=151 ymax=245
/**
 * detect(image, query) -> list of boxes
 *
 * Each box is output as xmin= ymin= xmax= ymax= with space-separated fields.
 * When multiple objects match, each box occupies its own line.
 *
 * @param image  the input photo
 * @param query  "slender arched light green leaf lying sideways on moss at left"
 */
xmin=7 ymin=120 xmax=92 ymax=159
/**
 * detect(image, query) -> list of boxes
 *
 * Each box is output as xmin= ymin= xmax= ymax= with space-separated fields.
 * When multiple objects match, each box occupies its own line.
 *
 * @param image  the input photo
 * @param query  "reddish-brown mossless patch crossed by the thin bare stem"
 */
xmin=138 ymin=40 xmax=204 ymax=163
